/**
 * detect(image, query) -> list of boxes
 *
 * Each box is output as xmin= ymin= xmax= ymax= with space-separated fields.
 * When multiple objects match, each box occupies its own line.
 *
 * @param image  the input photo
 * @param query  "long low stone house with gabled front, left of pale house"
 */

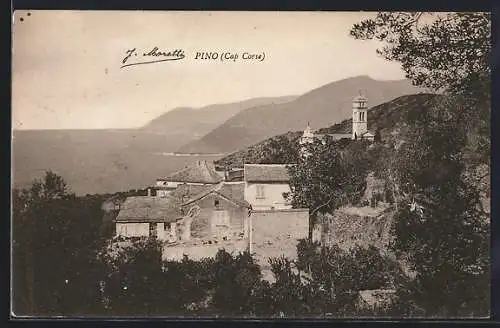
xmin=115 ymin=182 xmax=249 ymax=242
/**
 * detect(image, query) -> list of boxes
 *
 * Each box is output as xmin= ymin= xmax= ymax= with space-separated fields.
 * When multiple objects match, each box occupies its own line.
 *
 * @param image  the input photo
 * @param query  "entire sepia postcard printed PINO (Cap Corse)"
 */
xmin=10 ymin=10 xmax=492 ymax=320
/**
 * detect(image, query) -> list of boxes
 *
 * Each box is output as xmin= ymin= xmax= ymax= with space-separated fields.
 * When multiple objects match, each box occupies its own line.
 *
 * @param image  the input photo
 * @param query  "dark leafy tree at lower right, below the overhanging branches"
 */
xmin=388 ymin=110 xmax=489 ymax=315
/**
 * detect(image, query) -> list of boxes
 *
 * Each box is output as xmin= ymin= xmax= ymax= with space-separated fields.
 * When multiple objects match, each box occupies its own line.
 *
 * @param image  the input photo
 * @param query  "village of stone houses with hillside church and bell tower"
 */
xmin=101 ymin=95 xmax=390 ymax=292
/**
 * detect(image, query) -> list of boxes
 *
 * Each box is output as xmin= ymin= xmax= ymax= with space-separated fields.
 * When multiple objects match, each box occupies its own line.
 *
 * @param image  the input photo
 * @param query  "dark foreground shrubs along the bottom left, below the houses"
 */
xmin=13 ymin=172 xmax=406 ymax=317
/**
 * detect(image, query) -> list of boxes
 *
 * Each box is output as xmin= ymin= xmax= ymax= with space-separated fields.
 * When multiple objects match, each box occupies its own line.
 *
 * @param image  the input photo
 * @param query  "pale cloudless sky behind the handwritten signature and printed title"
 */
xmin=12 ymin=11 xmax=404 ymax=129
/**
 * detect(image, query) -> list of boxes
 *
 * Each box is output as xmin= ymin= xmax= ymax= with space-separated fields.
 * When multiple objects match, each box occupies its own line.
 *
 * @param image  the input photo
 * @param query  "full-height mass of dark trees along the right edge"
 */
xmin=351 ymin=13 xmax=491 ymax=315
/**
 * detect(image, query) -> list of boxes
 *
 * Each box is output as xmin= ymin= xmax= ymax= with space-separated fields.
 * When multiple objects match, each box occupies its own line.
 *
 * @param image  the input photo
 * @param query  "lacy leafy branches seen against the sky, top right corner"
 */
xmin=350 ymin=12 xmax=491 ymax=93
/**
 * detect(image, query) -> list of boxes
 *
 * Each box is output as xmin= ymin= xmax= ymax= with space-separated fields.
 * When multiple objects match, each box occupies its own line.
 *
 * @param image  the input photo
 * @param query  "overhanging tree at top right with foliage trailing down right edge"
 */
xmin=350 ymin=12 xmax=491 ymax=160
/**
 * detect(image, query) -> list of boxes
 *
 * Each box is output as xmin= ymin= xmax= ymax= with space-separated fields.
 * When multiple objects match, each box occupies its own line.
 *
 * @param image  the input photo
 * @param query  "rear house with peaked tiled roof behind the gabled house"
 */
xmin=154 ymin=160 xmax=224 ymax=197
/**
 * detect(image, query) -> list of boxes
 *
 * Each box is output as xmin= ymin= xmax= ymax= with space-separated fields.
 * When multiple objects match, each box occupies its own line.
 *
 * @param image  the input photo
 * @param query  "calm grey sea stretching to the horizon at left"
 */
xmin=11 ymin=131 xmax=225 ymax=195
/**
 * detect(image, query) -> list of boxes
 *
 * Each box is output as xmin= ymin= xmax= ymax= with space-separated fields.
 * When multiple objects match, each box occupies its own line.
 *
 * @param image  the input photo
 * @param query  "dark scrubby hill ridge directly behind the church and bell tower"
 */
xmin=215 ymin=93 xmax=439 ymax=167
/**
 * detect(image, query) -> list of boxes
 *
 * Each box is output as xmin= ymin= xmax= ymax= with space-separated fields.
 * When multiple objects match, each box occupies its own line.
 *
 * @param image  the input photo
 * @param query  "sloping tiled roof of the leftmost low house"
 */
xmin=116 ymin=196 xmax=181 ymax=222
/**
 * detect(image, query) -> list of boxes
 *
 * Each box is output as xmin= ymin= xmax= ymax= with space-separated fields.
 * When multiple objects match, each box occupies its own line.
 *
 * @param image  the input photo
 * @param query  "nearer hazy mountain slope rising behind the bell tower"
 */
xmin=179 ymin=76 xmax=422 ymax=153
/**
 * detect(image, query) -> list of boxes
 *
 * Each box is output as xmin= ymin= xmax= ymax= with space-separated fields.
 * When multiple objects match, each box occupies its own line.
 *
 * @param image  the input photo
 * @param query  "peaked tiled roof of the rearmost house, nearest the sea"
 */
xmin=158 ymin=161 xmax=222 ymax=184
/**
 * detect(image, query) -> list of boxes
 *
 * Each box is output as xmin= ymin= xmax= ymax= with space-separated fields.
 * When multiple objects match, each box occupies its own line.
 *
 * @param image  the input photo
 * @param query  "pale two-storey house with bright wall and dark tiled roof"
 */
xmin=244 ymin=164 xmax=292 ymax=210
